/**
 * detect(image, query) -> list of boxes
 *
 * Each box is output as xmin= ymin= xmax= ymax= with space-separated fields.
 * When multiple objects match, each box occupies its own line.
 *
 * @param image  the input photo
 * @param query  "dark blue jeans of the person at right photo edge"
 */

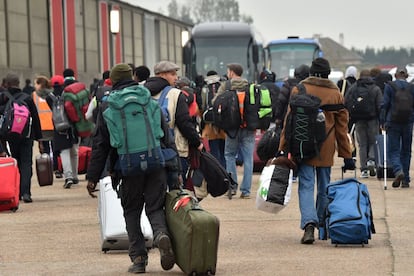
xmin=387 ymin=123 xmax=413 ymax=182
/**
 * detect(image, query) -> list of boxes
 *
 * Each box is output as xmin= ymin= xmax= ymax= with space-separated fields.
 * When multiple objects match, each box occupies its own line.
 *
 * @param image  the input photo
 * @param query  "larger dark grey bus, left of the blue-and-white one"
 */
xmin=183 ymin=22 xmax=265 ymax=82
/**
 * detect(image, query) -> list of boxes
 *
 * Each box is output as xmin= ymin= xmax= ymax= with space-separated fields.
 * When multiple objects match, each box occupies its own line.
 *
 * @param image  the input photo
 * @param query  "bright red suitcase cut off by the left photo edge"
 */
xmin=0 ymin=157 xmax=20 ymax=211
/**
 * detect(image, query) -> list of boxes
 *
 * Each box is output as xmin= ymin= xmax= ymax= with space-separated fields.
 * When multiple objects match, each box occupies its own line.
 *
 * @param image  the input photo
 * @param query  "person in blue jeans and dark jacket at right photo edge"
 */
xmin=380 ymin=67 xmax=414 ymax=188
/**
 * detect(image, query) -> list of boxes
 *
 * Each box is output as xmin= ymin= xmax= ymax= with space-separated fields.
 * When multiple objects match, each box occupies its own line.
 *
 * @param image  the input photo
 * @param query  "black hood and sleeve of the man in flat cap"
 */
xmin=144 ymin=77 xmax=201 ymax=148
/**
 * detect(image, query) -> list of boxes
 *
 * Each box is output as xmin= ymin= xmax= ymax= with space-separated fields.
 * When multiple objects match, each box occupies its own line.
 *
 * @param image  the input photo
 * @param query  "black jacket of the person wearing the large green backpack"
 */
xmin=87 ymin=80 xmax=175 ymax=183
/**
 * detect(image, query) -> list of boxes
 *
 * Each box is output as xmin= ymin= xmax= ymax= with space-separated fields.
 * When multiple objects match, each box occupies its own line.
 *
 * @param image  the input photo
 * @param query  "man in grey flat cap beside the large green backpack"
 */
xmin=144 ymin=61 xmax=203 ymax=189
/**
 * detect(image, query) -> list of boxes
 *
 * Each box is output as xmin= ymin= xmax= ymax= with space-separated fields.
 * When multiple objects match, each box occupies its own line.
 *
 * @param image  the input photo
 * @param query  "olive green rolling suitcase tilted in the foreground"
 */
xmin=165 ymin=190 xmax=219 ymax=275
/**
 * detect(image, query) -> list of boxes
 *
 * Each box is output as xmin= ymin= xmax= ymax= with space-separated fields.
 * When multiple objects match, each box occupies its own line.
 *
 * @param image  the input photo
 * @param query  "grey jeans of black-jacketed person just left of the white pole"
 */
xmin=355 ymin=119 xmax=379 ymax=171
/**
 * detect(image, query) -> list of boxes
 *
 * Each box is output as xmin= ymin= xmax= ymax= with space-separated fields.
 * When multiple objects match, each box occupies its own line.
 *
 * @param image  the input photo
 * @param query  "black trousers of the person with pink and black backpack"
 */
xmin=9 ymin=139 xmax=33 ymax=196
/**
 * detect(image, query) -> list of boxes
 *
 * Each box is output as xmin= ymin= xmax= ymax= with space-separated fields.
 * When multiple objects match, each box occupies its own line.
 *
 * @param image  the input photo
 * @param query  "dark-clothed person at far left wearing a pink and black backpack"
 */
xmin=0 ymin=73 xmax=42 ymax=203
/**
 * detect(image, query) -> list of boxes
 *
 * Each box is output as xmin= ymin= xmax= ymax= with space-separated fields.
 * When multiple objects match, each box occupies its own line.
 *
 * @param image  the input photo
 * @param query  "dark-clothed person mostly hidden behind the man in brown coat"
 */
xmin=275 ymin=64 xmax=309 ymax=127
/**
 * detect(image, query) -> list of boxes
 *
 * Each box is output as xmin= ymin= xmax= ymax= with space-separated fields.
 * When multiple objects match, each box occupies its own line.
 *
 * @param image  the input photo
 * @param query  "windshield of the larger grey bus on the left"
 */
xmin=194 ymin=37 xmax=253 ymax=79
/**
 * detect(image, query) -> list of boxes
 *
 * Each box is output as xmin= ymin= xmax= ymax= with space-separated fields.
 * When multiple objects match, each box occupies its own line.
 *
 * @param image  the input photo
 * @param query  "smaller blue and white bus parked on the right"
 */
xmin=265 ymin=36 xmax=323 ymax=83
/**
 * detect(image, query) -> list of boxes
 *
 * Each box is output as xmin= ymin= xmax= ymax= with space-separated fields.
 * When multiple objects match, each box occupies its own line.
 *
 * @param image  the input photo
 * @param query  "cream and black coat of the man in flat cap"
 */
xmin=144 ymin=77 xmax=201 ymax=157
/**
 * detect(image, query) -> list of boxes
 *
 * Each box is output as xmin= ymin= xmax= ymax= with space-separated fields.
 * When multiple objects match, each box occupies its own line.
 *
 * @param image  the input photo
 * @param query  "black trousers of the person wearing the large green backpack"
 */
xmin=121 ymin=169 xmax=168 ymax=261
